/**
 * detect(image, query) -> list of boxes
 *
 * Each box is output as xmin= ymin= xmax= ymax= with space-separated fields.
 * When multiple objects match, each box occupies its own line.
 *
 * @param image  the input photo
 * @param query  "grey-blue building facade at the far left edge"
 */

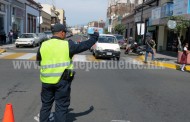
xmin=0 ymin=0 xmax=26 ymax=36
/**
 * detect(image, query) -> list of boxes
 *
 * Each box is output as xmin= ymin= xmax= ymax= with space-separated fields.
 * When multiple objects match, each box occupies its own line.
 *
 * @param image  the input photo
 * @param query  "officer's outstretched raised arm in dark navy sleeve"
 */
xmin=69 ymin=32 xmax=99 ymax=58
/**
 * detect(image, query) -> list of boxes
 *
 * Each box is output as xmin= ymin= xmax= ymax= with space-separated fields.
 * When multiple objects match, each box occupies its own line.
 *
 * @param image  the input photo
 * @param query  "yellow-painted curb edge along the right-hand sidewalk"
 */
xmin=135 ymin=56 xmax=190 ymax=71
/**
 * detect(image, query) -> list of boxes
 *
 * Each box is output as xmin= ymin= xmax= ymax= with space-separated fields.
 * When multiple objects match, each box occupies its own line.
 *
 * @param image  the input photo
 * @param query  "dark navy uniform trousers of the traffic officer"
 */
xmin=40 ymin=79 xmax=71 ymax=122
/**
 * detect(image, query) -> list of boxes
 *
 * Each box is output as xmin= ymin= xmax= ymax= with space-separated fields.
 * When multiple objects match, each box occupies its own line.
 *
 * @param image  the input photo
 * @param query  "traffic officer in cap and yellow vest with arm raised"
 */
xmin=37 ymin=24 xmax=99 ymax=122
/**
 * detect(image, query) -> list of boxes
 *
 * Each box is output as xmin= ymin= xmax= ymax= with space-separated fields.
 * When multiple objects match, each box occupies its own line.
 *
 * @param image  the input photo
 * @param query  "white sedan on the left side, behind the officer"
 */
xmin=15 ymin=33 xmax=39 ymax=47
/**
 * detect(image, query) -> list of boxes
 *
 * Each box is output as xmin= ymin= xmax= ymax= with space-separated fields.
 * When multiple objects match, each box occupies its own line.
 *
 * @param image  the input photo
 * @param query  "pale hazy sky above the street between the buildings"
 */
xmin=35 ymin=0 xmax=108 ymax=26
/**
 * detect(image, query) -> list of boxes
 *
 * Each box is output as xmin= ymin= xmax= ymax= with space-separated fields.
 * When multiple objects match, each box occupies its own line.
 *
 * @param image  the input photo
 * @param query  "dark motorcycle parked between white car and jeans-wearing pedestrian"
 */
xmin=125 ymin=42 xmax=145 ymax=55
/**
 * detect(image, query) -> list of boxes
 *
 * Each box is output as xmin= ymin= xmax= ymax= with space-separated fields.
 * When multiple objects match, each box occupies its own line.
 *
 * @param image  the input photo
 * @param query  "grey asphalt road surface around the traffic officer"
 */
xmin=0 ymin=34 xmax=190 ymax=122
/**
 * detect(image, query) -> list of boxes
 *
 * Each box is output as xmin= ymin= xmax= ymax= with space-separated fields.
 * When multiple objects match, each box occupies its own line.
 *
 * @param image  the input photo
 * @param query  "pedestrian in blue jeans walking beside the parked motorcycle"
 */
xmin=144 ymin=32 xmax=156 ymax=63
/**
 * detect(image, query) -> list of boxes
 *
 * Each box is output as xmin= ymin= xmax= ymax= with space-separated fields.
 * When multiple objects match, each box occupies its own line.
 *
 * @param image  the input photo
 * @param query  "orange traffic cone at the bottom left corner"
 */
xmin=3 ymin=104 xmax=15 ymax=122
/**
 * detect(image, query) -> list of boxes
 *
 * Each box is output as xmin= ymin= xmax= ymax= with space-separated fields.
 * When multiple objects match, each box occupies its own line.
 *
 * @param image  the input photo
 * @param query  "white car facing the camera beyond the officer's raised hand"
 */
xmin=93 ymin=34 xmax=121 ymax=60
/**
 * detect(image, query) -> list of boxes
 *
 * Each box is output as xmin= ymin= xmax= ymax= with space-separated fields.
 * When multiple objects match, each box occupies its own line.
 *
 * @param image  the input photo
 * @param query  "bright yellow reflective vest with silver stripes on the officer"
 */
xmin=40 ymin=39 xmax=73 ymax=84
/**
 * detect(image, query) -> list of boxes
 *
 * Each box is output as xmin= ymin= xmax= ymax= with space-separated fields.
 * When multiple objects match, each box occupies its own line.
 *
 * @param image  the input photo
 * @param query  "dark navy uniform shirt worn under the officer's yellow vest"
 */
xmin=36 ymin=33 xmax=99 ymax=65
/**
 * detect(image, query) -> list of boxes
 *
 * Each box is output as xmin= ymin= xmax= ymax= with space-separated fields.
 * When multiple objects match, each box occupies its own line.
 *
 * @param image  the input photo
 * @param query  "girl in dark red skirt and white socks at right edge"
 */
xmin=180 ymin=43 xmax=189 ymax=72
